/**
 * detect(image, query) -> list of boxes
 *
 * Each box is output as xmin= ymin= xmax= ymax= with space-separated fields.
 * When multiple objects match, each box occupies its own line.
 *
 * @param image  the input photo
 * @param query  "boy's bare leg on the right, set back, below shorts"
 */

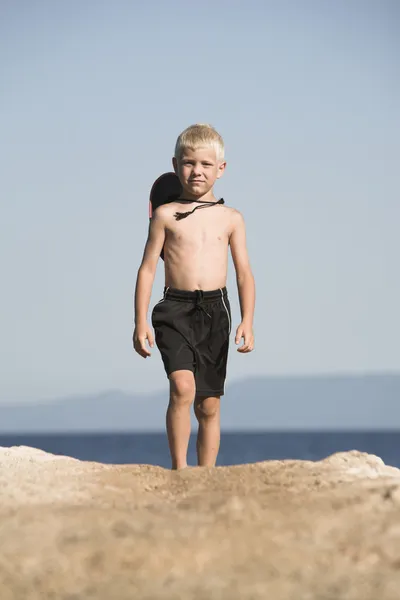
xmin=194 ymin=396 xmax=220 ymax=467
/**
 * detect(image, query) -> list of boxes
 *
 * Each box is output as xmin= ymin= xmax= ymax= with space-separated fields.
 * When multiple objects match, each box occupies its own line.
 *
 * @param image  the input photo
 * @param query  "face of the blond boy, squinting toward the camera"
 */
xmin=173 ymin=148 xmax=226 ymax=198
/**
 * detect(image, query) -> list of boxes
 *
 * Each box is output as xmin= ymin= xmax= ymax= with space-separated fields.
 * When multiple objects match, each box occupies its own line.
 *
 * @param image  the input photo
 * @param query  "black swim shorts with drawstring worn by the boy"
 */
xmin=151 ymin=288 xmax=231 ymax=396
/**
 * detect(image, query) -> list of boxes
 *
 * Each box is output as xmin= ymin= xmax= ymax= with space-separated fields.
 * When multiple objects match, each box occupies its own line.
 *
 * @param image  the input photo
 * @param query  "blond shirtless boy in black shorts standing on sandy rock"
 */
xmin=133 ymin=125 xmax=255 ymax=469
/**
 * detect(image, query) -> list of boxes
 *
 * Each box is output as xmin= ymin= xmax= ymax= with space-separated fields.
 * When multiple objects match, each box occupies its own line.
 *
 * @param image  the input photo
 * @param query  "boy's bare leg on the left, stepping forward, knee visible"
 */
xmin=166 ymin=370 xmax=196 ymax=469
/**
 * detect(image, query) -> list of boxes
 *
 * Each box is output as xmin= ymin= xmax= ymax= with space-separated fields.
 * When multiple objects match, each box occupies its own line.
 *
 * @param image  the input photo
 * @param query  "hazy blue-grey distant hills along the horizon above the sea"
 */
xmin=0 ymin=374 xmax=400 ymax=433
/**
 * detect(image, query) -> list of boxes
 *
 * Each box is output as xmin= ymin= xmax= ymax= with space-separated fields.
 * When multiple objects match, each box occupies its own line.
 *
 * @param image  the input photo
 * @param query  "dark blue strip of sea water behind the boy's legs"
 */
xmin=0 ymin=430 xmax=400 ymax=468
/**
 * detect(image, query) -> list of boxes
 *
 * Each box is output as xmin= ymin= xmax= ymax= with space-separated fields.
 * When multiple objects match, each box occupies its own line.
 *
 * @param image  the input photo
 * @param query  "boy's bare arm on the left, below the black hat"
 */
xmin=133 ymin=210 xmax=165 ymax=358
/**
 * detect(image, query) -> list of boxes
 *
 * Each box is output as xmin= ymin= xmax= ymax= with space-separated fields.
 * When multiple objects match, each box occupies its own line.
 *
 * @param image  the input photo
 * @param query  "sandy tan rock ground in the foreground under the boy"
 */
xmin=0 ymin=447 xmax=400 ymax=600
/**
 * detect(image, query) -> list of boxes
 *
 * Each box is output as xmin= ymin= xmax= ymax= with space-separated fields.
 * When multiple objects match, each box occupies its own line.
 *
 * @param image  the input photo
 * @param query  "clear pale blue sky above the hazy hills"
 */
xmin=0 ymin=0 xmax=400 ymax=402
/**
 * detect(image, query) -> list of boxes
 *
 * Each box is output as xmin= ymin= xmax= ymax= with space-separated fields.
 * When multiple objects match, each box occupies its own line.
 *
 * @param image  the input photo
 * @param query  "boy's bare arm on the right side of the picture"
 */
xmin=230 ymin=212 xmax=255 ymax=352
